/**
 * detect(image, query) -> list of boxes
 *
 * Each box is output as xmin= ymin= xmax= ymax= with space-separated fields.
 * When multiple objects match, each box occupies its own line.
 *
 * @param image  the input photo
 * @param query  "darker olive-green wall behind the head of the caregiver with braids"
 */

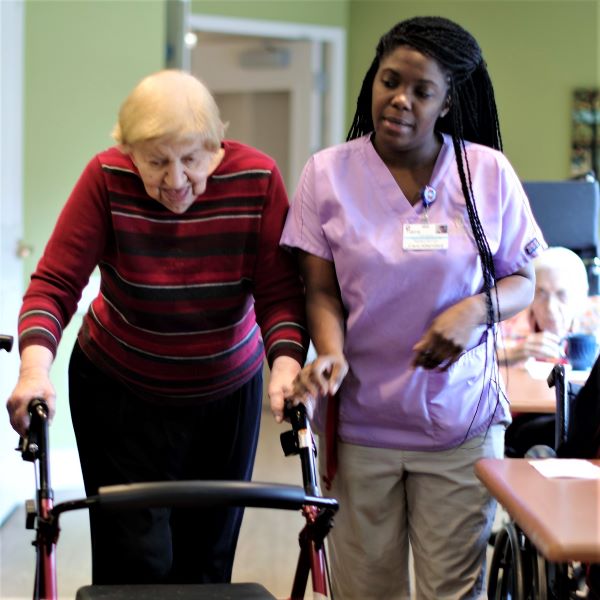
xmin=347 ymin=0 xmax=600 ymax=179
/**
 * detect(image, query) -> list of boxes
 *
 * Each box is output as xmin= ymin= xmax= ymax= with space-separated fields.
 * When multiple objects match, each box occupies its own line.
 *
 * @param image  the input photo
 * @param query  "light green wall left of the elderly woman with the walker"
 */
xmin=23 ymin=0 xmax=165 ymax=447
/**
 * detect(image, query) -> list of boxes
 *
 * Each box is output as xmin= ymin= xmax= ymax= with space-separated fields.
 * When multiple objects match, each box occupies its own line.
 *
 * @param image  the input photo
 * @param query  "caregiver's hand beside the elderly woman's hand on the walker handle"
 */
xmin=287 ymin=354 xmax=348 ymax=417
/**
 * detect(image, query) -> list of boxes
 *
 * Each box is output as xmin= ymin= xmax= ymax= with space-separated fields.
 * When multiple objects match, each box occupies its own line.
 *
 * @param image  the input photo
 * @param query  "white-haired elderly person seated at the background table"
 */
xmin=500 ymin=247 xmax=597 ymax=457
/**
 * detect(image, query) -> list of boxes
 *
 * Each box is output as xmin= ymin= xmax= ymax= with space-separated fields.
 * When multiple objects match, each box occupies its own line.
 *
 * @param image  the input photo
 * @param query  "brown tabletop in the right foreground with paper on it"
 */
xmin=475 ymin=458 xmax=600 ymax=563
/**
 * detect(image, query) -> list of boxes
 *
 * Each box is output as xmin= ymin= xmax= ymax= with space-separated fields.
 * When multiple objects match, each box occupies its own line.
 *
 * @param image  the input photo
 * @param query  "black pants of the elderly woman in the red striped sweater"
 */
xmin=69 ymin=344 xmax=262 ymax=584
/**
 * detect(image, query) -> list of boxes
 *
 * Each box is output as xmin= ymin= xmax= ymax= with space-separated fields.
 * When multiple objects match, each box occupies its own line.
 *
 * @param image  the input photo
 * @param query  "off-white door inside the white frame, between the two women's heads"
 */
xmin=191 ymin=33 xmax=323 ymax=195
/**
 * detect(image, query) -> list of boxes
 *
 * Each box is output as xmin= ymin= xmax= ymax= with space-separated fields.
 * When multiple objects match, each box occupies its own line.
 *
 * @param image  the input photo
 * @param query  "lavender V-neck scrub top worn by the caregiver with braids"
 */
xmin=281 ymin=135 xmax=545 ymax=450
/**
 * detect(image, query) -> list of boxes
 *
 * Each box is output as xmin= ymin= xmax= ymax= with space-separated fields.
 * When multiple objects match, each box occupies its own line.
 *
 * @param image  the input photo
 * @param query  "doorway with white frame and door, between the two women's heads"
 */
xmin=188 ymin=14 xmax=345 ymax=196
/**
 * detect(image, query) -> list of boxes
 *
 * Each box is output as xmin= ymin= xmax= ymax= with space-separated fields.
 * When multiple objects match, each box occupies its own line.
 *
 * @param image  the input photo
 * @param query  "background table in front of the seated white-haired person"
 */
xmin=500 ymin=363 xmax=589 ymax=413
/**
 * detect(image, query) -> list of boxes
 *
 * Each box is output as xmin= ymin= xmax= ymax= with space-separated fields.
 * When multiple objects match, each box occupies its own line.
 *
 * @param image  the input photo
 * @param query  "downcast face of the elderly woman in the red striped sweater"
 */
xmin=129 ymin=138 xmax=224 ymax=215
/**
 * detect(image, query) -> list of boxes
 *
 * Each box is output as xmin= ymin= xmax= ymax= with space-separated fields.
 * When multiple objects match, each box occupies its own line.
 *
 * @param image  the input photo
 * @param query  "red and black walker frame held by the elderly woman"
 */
xmin=18 ymin=399 xmax=338 ymax=600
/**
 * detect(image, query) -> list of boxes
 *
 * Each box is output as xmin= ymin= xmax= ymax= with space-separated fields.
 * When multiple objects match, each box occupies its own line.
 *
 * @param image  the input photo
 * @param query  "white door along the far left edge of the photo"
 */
xmin=0 ymin=0 xmax=27 ymax=523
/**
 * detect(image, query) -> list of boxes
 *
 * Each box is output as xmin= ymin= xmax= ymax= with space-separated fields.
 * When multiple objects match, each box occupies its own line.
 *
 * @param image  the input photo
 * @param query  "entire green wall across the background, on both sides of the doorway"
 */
xmin=18 ymin=0 xmax=600 ymax=447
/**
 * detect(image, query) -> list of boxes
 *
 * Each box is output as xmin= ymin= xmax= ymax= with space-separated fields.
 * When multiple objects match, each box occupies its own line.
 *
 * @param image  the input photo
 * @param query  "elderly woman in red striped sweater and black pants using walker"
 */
xmin=7 ymin=71 xmax=307 ymax=583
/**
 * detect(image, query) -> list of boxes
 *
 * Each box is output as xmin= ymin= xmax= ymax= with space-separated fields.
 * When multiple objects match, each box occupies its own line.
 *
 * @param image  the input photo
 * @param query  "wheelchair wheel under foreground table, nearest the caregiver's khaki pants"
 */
xmin=488 ymin=523 xmax=530 ymax=600
